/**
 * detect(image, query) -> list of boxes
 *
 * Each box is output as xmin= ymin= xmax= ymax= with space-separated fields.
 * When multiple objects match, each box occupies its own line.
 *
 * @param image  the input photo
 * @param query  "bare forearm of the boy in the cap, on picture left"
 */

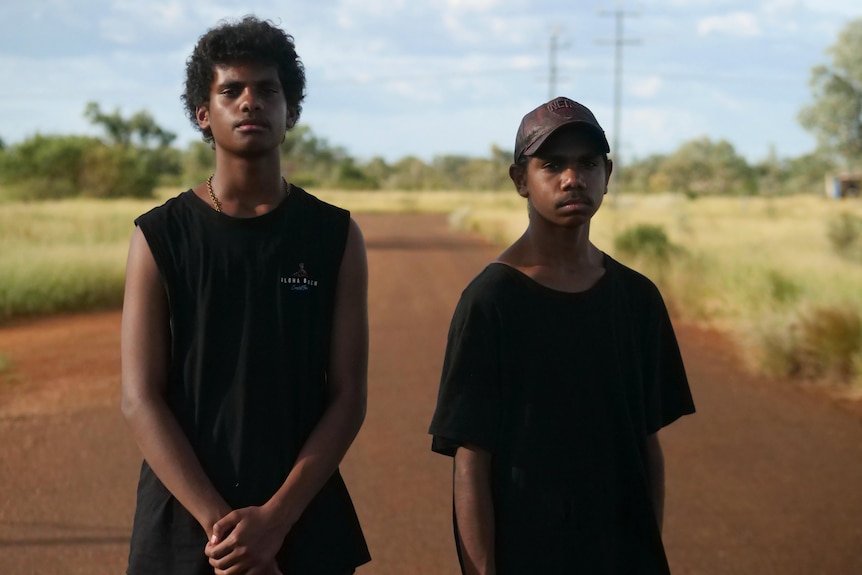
xmin=453 ymin=445 xmax=497 ymax=575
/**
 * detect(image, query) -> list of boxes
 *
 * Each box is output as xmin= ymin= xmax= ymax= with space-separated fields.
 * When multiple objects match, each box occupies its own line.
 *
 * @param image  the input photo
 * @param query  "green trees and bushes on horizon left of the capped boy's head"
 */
xmin=0 ymin=102 xmax=511 ymax=200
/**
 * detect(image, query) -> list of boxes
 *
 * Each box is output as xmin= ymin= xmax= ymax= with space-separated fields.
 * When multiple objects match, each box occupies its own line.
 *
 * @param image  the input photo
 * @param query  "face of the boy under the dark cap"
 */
xmin=509 ymin=126 xmax=613 ymax=227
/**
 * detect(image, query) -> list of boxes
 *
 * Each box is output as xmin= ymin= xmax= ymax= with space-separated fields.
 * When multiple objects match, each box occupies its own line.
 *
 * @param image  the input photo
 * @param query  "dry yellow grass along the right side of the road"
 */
xmin=463 ymin=194 xmax=862 ymax=383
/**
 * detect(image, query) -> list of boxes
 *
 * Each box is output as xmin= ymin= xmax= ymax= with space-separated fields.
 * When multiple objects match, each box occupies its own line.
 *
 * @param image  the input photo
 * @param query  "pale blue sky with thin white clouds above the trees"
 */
xmin=0 ymin=0 xmax=862 ymax=162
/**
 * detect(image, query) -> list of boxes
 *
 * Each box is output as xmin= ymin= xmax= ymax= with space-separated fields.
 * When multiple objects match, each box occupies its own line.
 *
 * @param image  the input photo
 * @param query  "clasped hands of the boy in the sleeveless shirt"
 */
xmin=205 ymin=507 xmax=286 ymax=575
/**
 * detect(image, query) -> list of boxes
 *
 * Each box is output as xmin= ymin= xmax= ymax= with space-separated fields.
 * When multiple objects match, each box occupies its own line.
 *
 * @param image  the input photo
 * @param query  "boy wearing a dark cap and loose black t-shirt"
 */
xmin=430 ymin=98 xmax=694 ymax=575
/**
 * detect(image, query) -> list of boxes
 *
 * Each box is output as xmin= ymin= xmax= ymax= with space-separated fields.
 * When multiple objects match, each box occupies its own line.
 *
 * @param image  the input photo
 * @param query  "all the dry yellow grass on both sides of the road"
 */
xmin=5 ymin=188 xmax=862 ymax=390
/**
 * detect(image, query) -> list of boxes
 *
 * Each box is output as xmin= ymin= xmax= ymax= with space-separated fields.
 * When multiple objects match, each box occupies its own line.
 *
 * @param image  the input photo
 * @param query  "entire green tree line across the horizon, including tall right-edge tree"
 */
xmin=0 ymin=18 xmax=862 ymax=200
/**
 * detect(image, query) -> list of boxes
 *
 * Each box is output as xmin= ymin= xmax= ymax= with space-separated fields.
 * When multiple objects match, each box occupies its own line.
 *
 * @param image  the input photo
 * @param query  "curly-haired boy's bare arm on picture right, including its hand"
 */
xmin=207 ymin=220 xmax=368 ymax=573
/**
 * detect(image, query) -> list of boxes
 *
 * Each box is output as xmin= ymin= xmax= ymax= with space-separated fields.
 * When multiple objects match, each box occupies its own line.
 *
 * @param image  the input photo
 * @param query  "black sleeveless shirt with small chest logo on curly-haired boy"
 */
xmin=129 ymin=186 xmax=370 ymax=574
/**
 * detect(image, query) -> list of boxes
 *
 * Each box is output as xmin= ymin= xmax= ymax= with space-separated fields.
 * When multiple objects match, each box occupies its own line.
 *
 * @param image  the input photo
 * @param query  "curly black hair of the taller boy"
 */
xmin=182 ymin=16 xmax=305 ymax=143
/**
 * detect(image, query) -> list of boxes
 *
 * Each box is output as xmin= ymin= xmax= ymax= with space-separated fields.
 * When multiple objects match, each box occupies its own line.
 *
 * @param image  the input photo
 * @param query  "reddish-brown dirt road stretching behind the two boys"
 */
xmin=0 ymin=215 xmax=862 ymax=575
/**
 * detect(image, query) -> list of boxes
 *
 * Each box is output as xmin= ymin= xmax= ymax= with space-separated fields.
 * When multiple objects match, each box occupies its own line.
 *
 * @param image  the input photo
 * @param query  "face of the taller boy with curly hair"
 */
xmin=197 ymin=64 xmax=296 ymax=155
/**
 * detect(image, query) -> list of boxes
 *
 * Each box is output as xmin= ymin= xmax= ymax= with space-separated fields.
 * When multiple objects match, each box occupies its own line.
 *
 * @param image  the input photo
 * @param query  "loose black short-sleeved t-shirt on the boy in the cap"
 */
xmin=430 ymin=256 xmax=694 ymax=575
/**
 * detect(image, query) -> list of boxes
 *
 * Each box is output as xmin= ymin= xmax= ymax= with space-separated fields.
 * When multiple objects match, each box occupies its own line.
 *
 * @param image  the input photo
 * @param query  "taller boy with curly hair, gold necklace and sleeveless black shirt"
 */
xmin=122 ymin=16 xmax=370 ymax=575
